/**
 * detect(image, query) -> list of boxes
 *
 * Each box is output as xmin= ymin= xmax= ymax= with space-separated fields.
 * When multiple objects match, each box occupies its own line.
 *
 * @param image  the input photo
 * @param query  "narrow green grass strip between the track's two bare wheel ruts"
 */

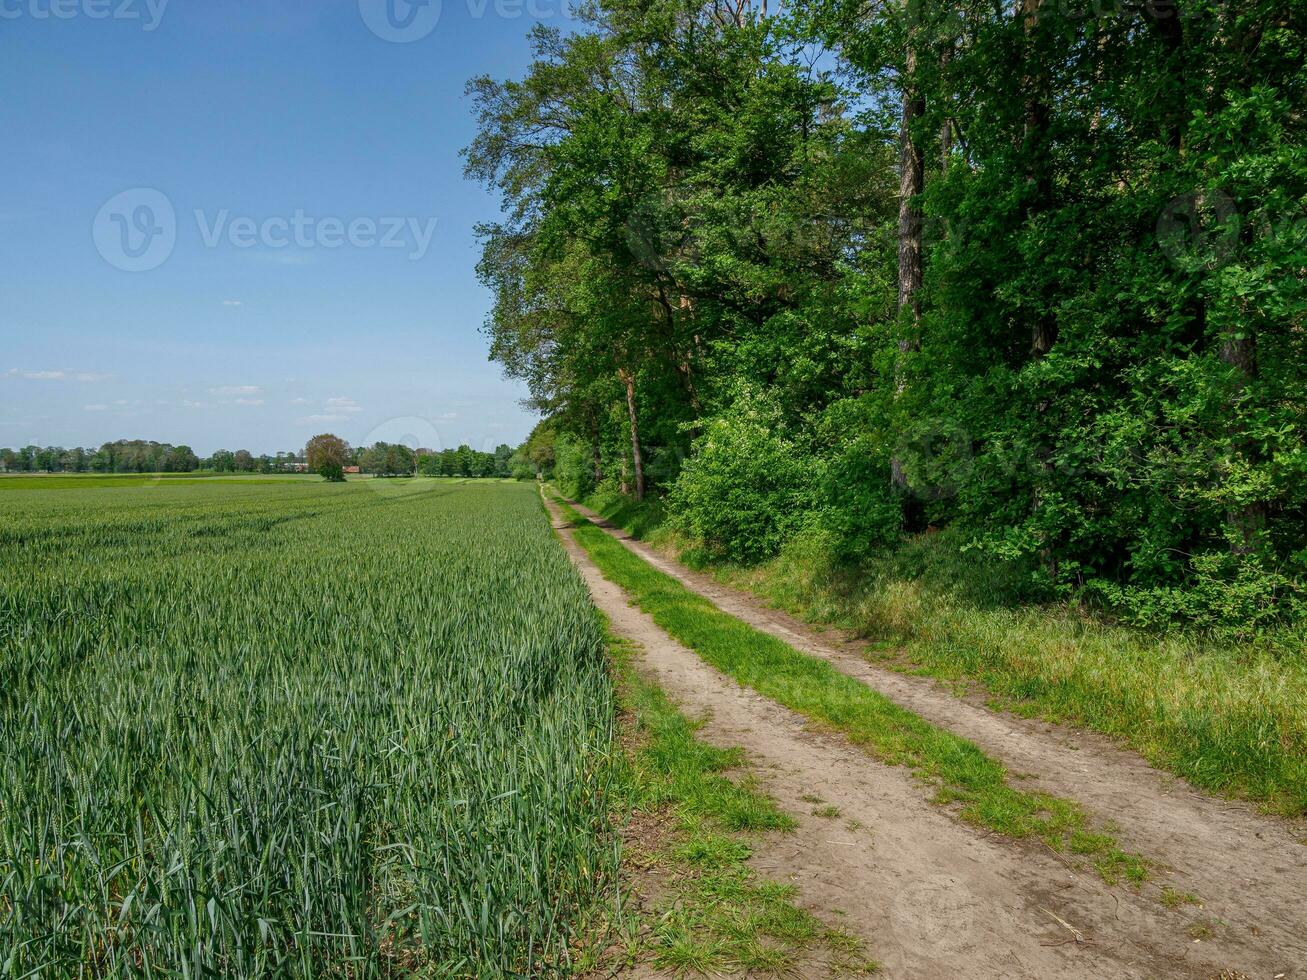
xmin=555 ymin=498 xmax=1148 ymax=882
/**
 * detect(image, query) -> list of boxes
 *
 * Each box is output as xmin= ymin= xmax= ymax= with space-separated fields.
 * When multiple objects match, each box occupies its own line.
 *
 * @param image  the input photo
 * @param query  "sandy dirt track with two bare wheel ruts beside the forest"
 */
xmin=554 ymin=499 xmax=1307 ymax=980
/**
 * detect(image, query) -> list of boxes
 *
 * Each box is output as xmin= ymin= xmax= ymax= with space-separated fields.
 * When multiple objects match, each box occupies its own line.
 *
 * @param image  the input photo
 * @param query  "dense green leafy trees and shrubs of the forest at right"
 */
xmin=478 ymin=0 xmax=1307 ymax=630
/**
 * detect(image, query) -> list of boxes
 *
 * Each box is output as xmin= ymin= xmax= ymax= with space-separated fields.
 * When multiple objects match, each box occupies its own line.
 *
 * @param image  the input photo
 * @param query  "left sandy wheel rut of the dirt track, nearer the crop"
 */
xmin=550 ymin=504 xmax=1289 ymax=980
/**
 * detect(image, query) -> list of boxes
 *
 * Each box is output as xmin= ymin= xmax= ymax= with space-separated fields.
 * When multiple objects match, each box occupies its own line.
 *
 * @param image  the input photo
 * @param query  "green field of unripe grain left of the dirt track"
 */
xmin=0 ymin=481 xmax=617 ymax=976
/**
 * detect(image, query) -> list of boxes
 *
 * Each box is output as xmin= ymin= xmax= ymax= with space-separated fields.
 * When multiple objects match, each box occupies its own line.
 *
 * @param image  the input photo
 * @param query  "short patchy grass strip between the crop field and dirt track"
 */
xmin=592 ymin=635 xmax=876 ymax=976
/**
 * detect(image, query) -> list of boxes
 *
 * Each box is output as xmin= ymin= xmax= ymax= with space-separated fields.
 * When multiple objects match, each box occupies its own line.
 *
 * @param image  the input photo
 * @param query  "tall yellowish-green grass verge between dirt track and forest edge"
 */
xmin=588 ymin=497 xmax=1307 ymax=818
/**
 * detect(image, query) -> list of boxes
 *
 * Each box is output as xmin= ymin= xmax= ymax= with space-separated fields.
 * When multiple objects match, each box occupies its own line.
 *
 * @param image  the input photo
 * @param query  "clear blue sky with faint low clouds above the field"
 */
xmin=0 ymin=0 xmax=570 ymax=453
